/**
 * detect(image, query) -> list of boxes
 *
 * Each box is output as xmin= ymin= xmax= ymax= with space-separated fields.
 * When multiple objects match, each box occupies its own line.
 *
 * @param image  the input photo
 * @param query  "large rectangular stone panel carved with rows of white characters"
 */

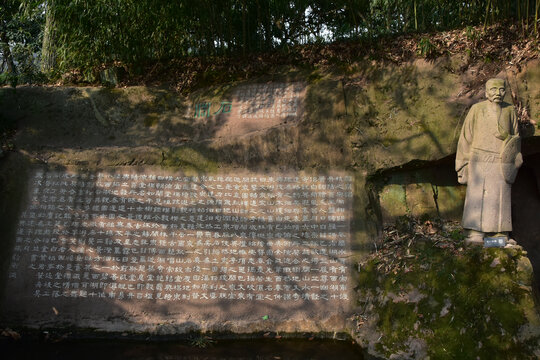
xmin=8 ymin=170 xmax=352 ymax=316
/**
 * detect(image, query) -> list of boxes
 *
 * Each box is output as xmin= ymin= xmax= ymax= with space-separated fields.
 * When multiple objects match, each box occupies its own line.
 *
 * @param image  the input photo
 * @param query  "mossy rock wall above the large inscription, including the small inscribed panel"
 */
xmin=0 ymin=56 xmax=540 ymax=338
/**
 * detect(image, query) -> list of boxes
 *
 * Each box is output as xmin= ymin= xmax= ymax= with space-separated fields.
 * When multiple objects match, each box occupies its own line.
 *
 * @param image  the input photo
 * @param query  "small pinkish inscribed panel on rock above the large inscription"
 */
xmin=188 ymin=82 xmax=306 ymax=137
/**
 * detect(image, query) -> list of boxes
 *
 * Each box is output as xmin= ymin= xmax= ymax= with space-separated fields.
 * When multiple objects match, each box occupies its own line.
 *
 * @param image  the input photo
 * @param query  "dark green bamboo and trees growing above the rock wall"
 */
xmin=0 ymin=0 xmax=540 ymax=76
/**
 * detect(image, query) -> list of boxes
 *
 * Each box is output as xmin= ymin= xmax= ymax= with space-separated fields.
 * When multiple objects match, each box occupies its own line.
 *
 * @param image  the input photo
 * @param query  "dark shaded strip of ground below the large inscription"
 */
xmin=0 ymin=329 xmax=363 ymax=360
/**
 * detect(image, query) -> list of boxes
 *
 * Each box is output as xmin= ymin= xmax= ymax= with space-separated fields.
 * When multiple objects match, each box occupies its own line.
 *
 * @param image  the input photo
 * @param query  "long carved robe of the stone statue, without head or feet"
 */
xmin=456 ymin=100 xmax=521 ymax=233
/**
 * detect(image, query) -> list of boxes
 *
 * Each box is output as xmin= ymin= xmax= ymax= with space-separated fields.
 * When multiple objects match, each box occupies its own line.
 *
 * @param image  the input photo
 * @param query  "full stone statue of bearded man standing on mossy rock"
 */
xmin=456 ymin=79 xmax=523 ymax=245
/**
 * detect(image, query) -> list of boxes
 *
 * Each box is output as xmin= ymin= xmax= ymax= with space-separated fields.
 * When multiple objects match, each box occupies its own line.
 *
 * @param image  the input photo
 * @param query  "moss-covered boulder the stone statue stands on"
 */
xmin=354 ymin=217 xmax=540 ymax=359
